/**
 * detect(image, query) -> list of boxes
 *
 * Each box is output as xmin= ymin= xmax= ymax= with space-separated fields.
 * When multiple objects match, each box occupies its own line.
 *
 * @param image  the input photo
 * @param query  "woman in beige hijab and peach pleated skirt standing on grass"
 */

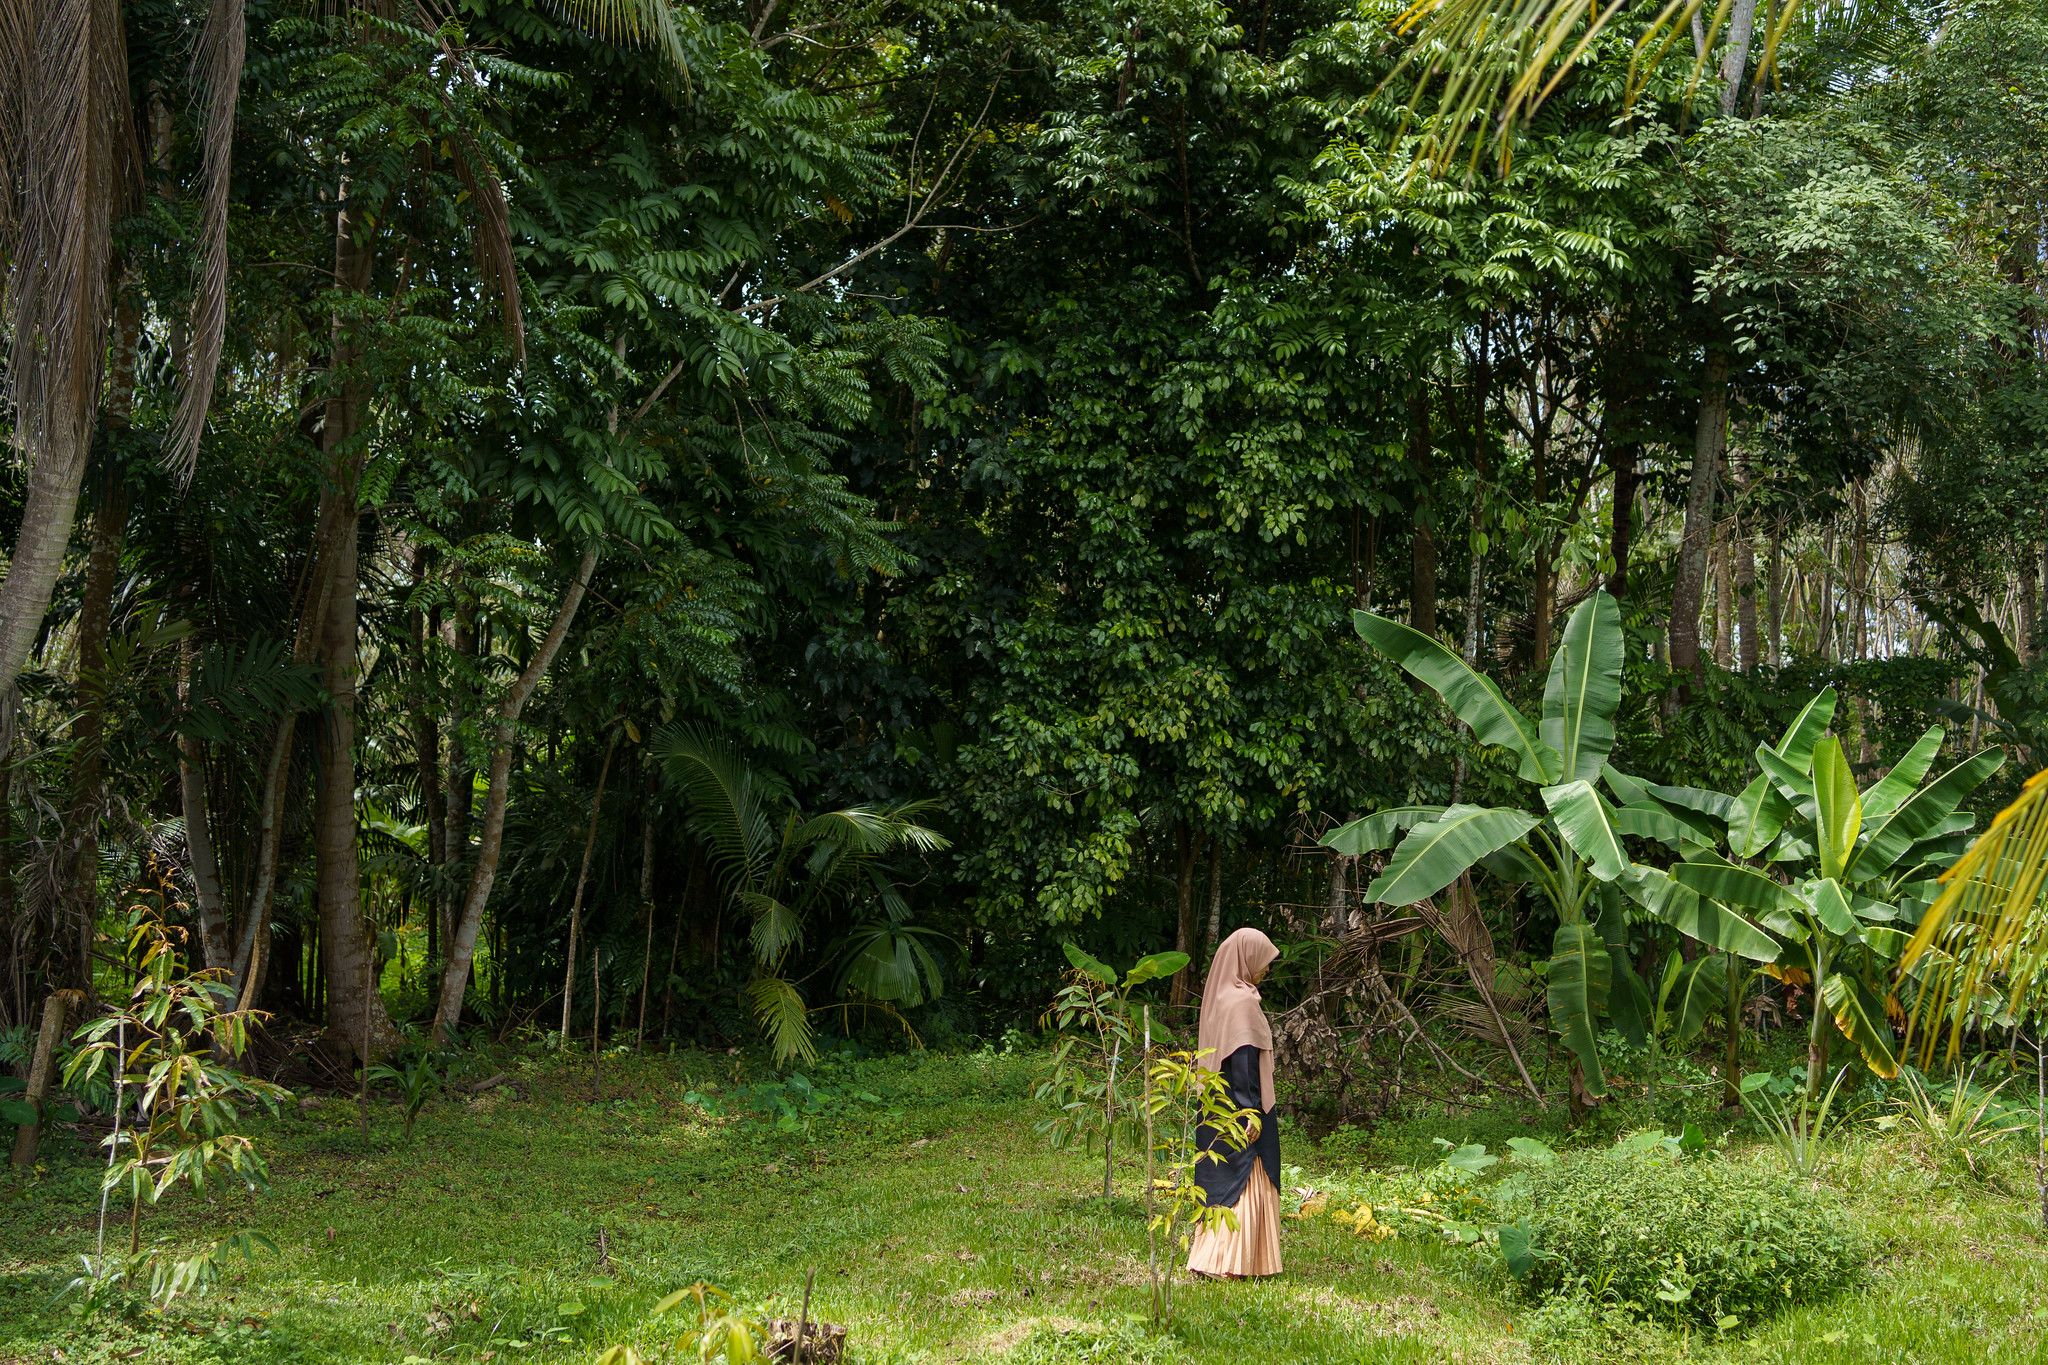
xmin=1188 ymin=929 xmax=1280 ymax=1279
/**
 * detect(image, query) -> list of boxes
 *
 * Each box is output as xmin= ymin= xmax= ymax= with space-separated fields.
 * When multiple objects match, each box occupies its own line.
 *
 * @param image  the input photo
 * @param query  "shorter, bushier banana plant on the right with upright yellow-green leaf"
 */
xmin=1604 ymin=688 xmax=2005 ymax=1105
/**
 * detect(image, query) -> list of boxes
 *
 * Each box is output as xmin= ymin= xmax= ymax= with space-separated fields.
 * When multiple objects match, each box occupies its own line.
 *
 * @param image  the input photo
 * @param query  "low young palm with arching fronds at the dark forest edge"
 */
xmin=653 ymin=726 xmax=946 ymax=1062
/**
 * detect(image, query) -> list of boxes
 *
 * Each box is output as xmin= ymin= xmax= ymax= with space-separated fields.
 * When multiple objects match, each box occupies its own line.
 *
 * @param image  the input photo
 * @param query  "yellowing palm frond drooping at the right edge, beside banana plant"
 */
xmin=1898 ymin=772 xmax=2048 ymax=1066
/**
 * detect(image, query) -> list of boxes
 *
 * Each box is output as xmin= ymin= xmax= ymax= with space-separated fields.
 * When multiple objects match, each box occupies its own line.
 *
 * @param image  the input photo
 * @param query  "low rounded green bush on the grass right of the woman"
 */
xmin=1524 ymin=1148 xmax=1870 ymax=1328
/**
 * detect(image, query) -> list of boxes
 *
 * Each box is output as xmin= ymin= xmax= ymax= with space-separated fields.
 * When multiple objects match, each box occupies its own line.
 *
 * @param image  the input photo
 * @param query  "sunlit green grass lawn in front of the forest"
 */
xmin=0 ymin=1052 xmax=2048 ymax=1365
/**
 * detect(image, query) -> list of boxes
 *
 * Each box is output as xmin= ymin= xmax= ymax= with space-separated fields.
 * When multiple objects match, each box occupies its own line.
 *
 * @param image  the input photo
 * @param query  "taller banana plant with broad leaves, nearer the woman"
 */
xmin=1323 ymin=591 xmax=1695 ymax=1099
